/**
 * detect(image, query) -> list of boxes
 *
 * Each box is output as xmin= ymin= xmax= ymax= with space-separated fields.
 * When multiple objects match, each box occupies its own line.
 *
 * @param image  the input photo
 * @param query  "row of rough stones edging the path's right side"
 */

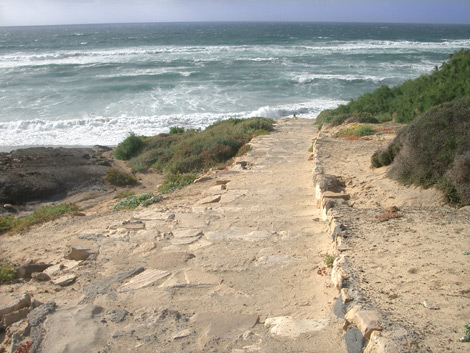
xmin=313 ymin=130 xmax=414 ymax=353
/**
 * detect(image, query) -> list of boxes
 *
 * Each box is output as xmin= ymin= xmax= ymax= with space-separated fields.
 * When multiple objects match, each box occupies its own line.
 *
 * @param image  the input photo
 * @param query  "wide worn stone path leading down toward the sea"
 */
xmin=0 ymin=119 xmax=345 ymax=353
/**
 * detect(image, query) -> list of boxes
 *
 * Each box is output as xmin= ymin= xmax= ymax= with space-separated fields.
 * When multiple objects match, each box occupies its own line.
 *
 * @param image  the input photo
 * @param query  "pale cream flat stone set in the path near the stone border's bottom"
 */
xmin=264 ymin=316 xmax=328 ymax=338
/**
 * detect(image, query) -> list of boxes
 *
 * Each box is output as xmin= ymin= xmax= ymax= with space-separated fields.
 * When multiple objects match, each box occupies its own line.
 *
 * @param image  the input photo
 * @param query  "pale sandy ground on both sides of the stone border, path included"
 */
xmin=0 ymin=119 xmax=470 ymax=353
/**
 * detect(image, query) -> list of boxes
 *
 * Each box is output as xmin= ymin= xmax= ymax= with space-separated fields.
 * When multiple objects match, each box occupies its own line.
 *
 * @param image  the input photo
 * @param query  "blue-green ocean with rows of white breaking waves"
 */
xmin=0 ymin=23 xmax=470 ymax=150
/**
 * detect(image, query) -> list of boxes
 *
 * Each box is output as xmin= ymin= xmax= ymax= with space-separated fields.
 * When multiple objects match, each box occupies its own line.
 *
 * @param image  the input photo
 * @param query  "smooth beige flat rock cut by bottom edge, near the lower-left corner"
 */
xmin=40 ymin=305 xmax=104 ymax=353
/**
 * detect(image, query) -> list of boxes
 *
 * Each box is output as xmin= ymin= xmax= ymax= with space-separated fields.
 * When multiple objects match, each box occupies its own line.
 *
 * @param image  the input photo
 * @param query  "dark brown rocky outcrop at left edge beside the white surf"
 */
xmin=0 ymin=147 xmax=110 ymax=205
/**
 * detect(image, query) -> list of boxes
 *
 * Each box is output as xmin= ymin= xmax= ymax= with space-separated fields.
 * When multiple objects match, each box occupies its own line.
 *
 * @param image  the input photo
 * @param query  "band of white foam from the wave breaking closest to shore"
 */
xmin=0 ymin=99 xmax=346 ymax=146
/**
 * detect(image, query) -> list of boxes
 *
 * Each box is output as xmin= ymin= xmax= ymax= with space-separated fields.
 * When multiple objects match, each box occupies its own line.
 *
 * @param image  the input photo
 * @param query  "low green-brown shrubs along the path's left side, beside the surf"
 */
xmin=115 ymin=118 xmax=273 ymax=192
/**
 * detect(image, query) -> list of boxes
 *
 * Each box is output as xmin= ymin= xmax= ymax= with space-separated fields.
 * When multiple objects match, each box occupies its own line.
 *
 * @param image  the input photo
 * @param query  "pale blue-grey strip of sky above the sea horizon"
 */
xmin=0 ymin=0 xmax=470 ymax=26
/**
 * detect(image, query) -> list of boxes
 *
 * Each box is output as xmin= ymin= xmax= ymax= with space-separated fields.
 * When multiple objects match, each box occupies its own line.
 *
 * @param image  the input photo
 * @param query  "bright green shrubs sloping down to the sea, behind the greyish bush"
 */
xmin=316 ymin=50 xmax=470 ymax=125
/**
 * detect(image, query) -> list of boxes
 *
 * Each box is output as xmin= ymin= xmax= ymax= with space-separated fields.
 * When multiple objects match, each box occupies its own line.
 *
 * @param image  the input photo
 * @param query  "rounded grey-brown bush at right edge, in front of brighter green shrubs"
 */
xmin=389 ymin=97 xmax=470 ymax=206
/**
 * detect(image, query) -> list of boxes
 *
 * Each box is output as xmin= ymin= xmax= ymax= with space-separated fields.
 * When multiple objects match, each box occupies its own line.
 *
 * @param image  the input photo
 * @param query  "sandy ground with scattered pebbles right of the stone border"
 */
xmin=318 ymin=124 xmax=470 ymax=352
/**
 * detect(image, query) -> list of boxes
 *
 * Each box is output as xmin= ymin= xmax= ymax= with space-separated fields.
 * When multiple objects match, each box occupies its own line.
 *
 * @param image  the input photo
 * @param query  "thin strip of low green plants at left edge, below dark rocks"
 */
xmin=0 ymin=203 xmax=80 ymax=234
